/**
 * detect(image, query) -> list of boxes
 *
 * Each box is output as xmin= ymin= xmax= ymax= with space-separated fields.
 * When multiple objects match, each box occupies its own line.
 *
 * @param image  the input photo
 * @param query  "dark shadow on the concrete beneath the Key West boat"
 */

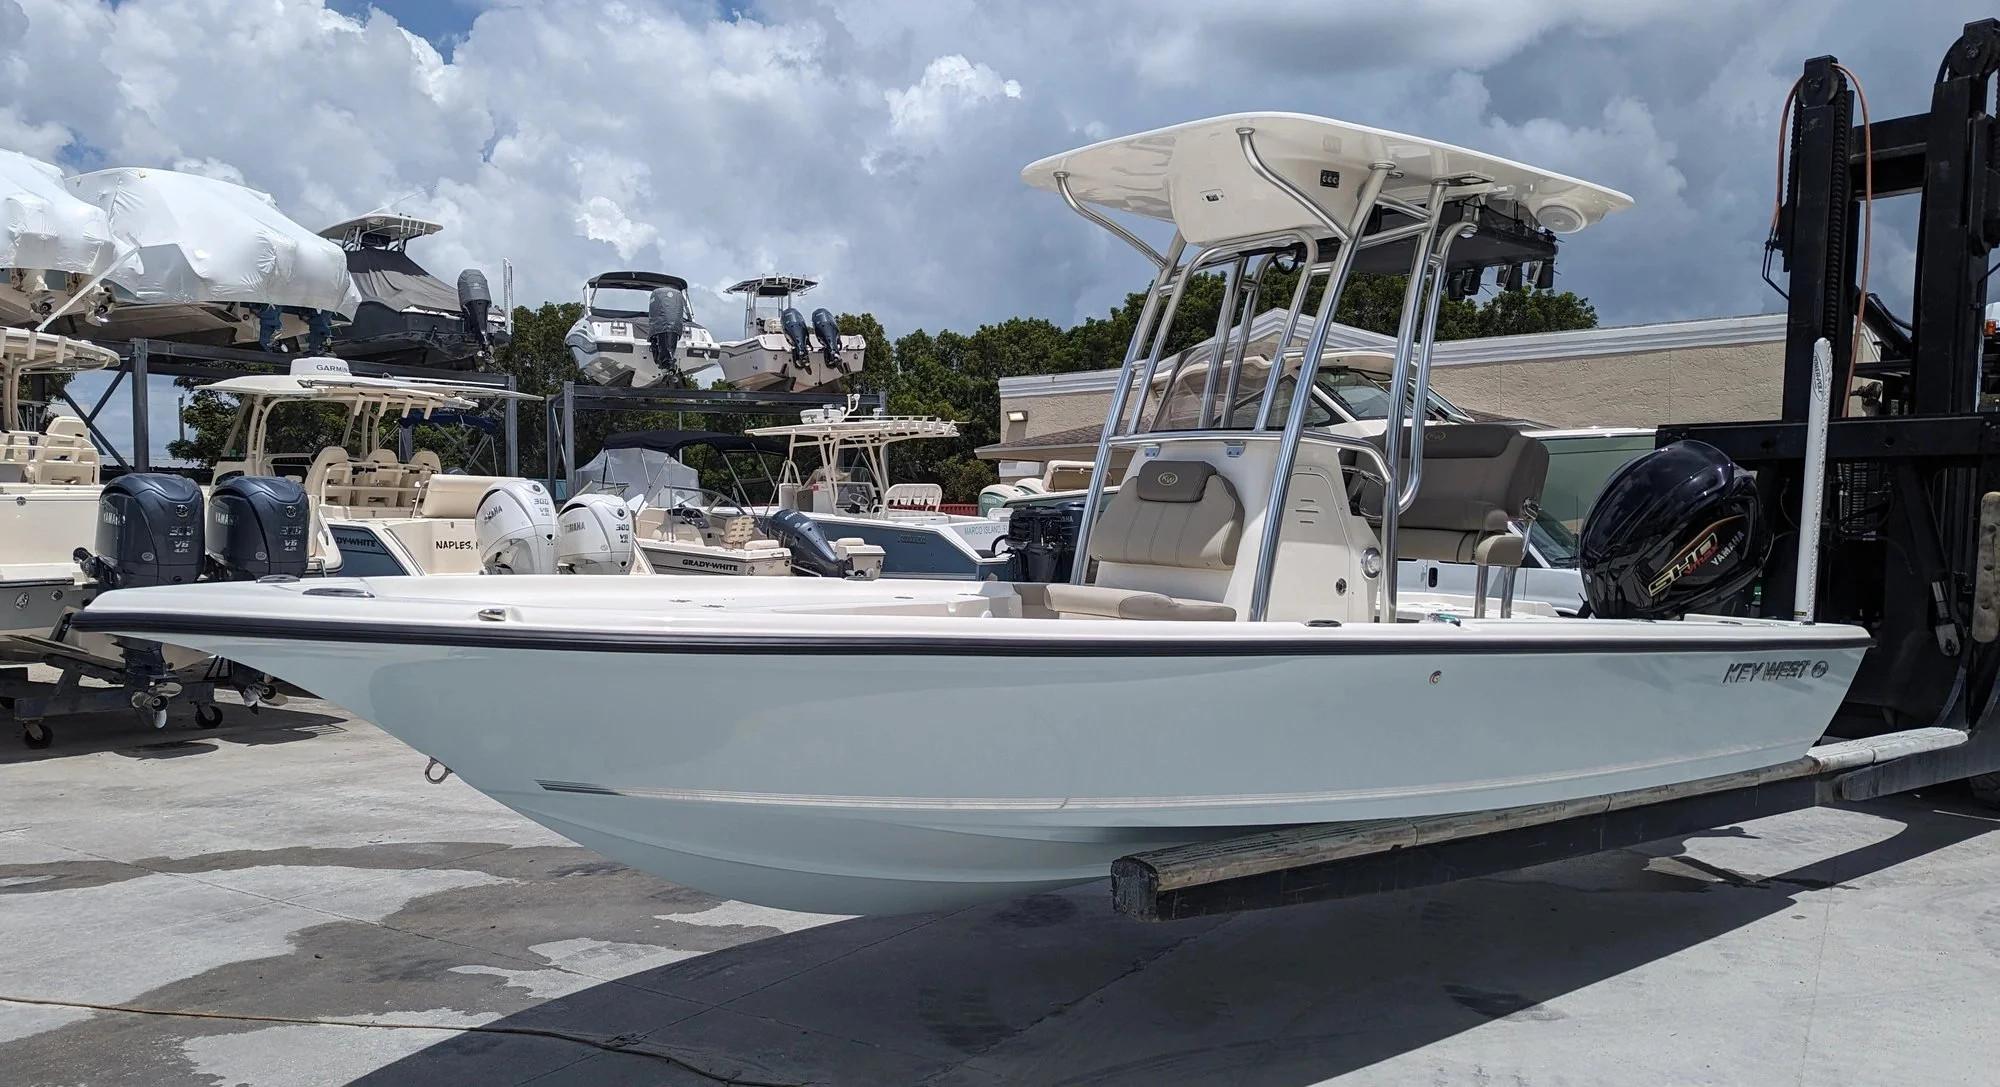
xmin=356 ymin=799 xmax=1994 ymax=1087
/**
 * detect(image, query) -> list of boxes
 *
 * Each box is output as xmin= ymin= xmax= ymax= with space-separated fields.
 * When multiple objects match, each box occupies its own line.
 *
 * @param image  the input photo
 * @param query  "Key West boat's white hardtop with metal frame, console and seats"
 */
xmin=1022 ymin=114 xmax=1630 ymax=621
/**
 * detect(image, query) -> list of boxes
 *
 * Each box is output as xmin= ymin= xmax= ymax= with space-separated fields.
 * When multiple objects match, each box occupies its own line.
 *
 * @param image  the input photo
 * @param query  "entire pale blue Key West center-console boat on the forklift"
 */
xmin=78 ymin=114 xmax=1868 ymax=911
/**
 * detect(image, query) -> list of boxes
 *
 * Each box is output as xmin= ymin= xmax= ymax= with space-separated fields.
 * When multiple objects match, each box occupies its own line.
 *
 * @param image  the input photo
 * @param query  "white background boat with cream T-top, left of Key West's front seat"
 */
xmin=750 ymin=398 xmax=1012 ymax=581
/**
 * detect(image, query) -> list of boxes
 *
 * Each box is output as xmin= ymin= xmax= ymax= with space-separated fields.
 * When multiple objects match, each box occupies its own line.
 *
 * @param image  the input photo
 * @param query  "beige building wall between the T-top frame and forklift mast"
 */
xmin=1430 ymin=342 xmax=1784 ymax=426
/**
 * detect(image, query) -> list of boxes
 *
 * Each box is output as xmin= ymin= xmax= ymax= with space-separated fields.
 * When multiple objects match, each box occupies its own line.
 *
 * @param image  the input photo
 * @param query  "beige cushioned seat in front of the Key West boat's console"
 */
xmin=1048 ymin=460 xmax=1244 ymax=623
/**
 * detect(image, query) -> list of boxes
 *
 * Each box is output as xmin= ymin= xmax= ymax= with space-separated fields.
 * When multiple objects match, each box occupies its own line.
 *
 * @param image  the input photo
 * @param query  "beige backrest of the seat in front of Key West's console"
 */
xmin=1090 ymin=460 xmax=1244 ymax=569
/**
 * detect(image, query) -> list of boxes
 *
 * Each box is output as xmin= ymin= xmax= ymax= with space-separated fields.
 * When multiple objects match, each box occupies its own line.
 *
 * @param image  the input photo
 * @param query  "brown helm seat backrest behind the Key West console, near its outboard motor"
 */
xmin=1362 ymin=424 xmax=1548 ymax=561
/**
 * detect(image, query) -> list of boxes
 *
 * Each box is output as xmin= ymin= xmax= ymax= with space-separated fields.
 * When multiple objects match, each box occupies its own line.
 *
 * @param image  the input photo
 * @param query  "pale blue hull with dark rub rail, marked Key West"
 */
xmin=70 ymin=577 xmax=1866 ymax=913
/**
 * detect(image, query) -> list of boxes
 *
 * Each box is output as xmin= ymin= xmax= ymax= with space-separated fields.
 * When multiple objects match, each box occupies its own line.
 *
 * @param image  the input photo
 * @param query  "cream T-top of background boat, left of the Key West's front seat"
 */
xmin=750 ymin=396 xmax=958 ymax=516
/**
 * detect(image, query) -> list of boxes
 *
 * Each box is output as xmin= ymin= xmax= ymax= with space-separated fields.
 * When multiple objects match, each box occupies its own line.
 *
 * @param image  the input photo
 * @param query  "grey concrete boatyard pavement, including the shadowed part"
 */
xmin=0 ymin=701 xmax=2000 ymax=1087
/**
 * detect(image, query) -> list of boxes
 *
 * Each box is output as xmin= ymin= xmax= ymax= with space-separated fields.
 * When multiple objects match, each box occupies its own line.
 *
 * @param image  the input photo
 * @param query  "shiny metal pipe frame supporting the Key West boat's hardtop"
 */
xmin=1056 ymin=128 xmax=1486 ymax=623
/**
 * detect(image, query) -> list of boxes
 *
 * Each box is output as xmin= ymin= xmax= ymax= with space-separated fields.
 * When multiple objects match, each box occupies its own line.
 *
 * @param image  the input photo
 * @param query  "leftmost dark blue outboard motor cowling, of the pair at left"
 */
xmin=74 ymin=472 xmax=206 ymax=589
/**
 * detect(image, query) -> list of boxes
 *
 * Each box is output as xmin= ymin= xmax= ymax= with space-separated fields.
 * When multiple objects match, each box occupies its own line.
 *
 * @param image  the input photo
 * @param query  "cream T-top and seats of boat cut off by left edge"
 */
xmin=0 ymin=328 xmax=118 ymax=486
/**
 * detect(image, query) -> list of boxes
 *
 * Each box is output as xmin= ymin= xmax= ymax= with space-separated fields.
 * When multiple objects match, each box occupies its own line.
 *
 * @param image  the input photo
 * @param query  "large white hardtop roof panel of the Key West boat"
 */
xmin=1020 ymin=114 xmax=1632 ymax=246
